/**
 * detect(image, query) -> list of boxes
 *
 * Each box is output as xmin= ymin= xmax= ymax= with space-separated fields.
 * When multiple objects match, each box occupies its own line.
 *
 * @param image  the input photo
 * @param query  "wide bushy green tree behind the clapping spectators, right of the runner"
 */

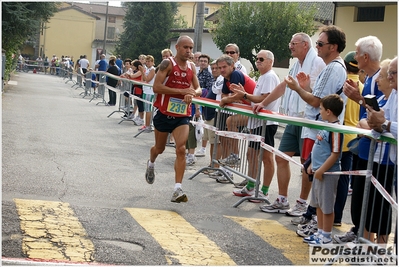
xmin=211 ymin=2 xmax=316 ymax=69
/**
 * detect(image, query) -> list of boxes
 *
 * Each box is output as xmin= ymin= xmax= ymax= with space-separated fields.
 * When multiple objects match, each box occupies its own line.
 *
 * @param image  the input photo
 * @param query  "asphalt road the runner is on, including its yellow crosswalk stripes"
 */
xmin=2 ymin=73 xmax=350 ymax=265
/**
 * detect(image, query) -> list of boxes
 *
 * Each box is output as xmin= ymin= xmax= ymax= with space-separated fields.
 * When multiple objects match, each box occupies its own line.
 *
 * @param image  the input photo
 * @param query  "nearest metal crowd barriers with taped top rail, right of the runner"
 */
xmin=188 ymin=98 xmax=398 ymax=251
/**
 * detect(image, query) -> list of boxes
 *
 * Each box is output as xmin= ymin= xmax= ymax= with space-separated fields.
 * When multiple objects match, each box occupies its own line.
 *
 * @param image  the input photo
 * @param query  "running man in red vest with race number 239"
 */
xmin=145 ymin=35 xmax=202 ymax=203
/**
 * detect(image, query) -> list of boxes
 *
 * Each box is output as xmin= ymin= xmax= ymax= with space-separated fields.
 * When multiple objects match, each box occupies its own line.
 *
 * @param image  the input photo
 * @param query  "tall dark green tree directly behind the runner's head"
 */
xmin=116 ymin=2 xmax=177 ymax=64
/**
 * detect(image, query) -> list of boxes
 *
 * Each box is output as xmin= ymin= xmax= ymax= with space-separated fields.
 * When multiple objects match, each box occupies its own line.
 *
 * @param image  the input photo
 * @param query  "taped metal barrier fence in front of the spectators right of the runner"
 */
xmin=189 ymin=98 xmax=398 ymax=264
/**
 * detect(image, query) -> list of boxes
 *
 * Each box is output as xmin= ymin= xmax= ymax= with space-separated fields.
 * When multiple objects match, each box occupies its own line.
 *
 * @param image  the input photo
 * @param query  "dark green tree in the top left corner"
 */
xmin=1 ymin=2 xmax=58 ymax=77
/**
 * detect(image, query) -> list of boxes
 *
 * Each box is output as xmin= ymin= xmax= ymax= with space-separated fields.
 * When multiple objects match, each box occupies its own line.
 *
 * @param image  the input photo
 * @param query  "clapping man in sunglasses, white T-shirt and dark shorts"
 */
xmin=230 ymin=50 xmax=280 ymax=202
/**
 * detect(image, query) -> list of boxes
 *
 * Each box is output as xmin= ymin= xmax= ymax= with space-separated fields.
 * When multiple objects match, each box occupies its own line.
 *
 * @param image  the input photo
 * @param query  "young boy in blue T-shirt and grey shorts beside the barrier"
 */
xmin=303 ymin=94 xmax=344 ymax=246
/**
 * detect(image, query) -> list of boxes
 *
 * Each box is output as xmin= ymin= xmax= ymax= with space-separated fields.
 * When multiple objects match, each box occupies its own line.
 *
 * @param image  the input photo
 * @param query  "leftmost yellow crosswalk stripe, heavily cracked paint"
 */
xmin=14 ymin=199 xmax=94 ymax=262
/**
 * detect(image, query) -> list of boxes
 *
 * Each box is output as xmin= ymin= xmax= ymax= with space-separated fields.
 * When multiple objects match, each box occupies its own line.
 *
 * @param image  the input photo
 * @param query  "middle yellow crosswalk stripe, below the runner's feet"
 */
xmin=126 ymin=208 xmax=236 ymax=266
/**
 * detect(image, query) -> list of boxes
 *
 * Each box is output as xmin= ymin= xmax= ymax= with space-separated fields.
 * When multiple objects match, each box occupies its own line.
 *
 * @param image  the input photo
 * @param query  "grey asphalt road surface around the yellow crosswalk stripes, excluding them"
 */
xmin=2 ymin=73 xmax=356 ymax=266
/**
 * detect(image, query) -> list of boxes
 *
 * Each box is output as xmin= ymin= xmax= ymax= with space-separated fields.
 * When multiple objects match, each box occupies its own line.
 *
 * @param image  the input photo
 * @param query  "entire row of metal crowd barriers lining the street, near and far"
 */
xmin=22 ymin=68 xmax=398 ymax=257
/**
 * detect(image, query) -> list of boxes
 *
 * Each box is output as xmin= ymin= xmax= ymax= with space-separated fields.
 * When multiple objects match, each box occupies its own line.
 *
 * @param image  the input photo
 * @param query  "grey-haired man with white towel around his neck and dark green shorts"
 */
xmin=253 ymin=33 xmax=326 ymax=219
